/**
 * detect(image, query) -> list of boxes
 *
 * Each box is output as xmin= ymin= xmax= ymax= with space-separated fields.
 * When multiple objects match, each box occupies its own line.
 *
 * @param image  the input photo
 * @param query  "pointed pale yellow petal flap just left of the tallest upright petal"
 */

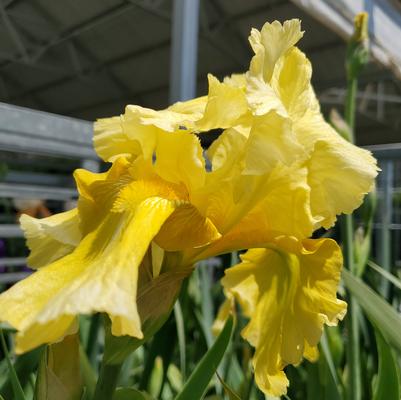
xmin=196 ymin=74 xmax=248 ymax=131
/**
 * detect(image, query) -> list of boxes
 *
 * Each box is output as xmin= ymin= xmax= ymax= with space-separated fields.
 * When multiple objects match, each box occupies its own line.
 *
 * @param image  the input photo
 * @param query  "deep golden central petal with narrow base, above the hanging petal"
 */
xmin=184 ymin=165 xmax=315 ymax=262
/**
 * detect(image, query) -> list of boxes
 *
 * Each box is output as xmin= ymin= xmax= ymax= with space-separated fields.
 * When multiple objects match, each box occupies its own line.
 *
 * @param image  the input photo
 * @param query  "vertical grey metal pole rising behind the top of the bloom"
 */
xmin=170 ymin=0 xmax=199 ymax=103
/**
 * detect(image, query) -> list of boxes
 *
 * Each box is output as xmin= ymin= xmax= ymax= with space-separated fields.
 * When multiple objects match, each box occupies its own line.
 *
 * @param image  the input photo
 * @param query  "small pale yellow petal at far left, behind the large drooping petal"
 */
xmin=20 ymin=208 xmax=81 ymax=268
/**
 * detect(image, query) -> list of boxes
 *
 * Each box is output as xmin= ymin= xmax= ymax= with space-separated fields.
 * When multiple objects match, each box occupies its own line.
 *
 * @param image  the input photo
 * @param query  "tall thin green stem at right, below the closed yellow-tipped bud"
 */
xmin=341 ymin=77 xmax=362 ymax=400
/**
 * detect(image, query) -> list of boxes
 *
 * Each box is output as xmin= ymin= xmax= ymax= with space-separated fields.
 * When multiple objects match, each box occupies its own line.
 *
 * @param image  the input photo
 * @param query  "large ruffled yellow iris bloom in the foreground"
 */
xmin=0 ymin=20 xmax=377 ymax=395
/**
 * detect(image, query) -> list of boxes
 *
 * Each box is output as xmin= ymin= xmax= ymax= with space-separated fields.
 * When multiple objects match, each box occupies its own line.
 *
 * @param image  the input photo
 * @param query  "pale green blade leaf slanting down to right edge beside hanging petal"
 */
xmin=343 ymin=268 xmax=401 ymax=351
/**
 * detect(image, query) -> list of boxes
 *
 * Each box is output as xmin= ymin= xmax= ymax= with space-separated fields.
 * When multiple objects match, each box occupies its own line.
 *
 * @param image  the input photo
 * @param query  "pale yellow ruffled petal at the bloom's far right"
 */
xmin=298 ymin=115 xmax=378 ymax=228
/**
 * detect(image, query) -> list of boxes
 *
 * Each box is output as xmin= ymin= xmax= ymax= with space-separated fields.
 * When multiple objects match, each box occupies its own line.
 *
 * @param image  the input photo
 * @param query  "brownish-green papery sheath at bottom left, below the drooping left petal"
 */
xmin=34 ymin=335 xmax=82 ymax=400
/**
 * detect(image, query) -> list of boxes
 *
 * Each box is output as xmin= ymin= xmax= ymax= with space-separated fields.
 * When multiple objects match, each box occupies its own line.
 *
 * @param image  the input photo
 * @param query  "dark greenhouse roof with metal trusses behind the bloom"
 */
xmin=0 ymin=0 xmax=401 ymax=145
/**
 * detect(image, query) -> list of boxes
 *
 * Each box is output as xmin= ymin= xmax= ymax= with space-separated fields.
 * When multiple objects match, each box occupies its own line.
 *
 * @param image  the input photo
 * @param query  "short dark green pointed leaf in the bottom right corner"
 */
xmin=373 ymin=328 xmax=401 ymax=400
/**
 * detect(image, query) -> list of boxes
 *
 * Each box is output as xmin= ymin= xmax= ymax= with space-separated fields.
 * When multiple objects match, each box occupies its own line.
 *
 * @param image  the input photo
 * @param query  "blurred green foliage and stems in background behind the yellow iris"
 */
xmin=0 ymin=4 xmax=401 ymax=400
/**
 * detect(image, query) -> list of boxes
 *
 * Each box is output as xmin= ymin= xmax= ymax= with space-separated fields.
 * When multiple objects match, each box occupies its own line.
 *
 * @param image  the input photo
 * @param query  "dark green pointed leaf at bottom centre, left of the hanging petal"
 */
xmin=176 ymin=316 xmax=234 ymax=400
